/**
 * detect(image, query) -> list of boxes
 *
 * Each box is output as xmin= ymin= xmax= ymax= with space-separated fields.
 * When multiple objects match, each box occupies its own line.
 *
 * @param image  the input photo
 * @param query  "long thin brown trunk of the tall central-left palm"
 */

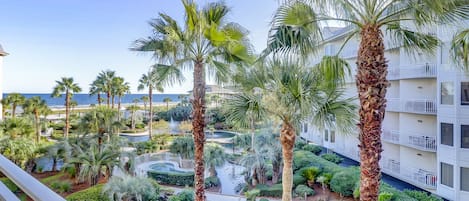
xmin=192 ymin=60 xmax=205 ymax=201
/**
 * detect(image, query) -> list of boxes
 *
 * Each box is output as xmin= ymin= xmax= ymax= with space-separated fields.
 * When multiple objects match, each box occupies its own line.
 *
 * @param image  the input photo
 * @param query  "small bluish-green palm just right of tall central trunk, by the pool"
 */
xmin=204 ymin=143 xmax=226 ymax=177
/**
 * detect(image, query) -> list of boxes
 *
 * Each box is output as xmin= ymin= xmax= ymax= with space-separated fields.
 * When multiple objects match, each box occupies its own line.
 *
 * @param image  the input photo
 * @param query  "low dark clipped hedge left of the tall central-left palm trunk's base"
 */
xmin=148 ymin=171 xmax=194 ymax=186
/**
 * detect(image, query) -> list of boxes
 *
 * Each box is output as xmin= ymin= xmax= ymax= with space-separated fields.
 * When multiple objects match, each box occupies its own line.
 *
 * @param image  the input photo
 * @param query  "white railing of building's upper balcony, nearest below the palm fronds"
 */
xmin=399 ymin=63 xmax=437 ymax=79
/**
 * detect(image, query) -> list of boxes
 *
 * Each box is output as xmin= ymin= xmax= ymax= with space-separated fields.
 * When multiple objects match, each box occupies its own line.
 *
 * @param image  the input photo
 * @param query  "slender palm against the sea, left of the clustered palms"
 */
xmin=52 ymin=77 xmax=81 ymax=138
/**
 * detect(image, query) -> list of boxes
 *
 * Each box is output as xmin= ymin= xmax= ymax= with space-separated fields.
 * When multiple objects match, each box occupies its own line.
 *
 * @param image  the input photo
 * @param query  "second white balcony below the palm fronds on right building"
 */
xmin=386 ymin=98 xmax=438 ymax=115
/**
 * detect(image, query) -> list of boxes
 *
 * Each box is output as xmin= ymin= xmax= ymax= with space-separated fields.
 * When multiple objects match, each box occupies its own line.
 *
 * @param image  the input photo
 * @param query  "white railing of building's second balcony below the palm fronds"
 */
xmin=401 ymin=99 xmax=438 ymax=114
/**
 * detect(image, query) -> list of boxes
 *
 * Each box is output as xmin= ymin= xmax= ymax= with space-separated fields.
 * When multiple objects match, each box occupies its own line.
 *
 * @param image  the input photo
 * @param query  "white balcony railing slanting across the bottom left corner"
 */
xmin=0 ymin=154 xmax=65 ymax=201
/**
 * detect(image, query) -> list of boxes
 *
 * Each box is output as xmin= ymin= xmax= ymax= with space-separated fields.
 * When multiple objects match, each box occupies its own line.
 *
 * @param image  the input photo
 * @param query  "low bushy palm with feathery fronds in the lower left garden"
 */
xmin=70 ymin=143 xmax=119 ymax=186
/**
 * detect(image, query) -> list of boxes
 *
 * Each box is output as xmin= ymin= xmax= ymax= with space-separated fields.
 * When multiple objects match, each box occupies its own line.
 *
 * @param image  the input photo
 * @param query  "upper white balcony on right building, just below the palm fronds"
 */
xmin=387 ymin=63 xmax=437 ymax=80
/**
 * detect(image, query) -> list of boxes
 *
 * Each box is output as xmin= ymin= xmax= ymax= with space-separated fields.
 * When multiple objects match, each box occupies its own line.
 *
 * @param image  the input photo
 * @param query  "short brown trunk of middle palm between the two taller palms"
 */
xmin=280 ymin=121 xmax=296 ymax=201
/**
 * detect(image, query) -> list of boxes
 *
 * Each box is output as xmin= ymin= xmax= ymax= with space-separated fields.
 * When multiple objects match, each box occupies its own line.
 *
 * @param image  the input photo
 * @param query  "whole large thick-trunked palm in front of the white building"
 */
xmin=266 ymin=0 xmax=469 ymax=200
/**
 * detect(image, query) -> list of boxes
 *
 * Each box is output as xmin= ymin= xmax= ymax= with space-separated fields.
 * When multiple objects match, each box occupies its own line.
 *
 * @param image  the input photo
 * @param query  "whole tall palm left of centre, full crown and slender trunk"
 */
xmin=133 ymin=0 xmax=251 ymax=201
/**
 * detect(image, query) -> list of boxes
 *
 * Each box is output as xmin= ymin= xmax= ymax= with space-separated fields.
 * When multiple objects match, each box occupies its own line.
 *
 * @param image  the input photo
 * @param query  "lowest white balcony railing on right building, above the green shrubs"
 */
xmin=401 ymin=167 xmax=438 ymax=189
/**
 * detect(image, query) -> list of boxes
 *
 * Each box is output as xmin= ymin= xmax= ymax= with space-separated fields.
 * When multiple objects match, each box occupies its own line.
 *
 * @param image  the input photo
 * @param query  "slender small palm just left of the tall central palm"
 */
xmin=137 ymin=67 xmax=163 ymax=139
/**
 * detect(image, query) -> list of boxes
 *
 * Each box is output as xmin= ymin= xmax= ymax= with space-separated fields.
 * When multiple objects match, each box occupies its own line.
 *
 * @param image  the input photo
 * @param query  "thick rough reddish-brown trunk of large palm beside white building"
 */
xmin=356 ymin=25 xmax=389 ymax=201
